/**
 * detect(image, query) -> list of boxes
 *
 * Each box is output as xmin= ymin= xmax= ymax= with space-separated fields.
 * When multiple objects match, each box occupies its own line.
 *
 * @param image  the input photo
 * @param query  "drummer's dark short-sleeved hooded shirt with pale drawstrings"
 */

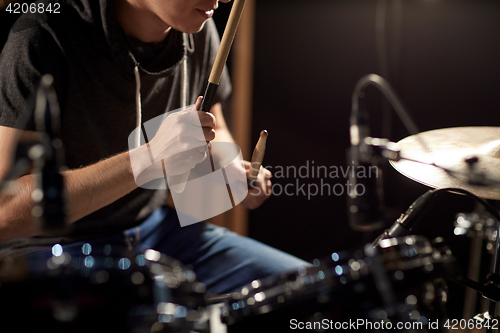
xmin=0 ymin=0 xmax=231 ymax=254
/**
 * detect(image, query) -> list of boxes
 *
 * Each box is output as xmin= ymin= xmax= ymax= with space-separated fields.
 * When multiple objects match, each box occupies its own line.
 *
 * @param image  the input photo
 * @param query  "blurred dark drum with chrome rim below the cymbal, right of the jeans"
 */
xmin=223 ymin=236 xmax=457 ymax=332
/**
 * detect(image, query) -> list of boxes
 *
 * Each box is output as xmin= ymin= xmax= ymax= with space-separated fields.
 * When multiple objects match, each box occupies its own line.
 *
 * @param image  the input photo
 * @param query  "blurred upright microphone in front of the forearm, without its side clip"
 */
xmin=32 ymin=75 xmax=66 ymax=232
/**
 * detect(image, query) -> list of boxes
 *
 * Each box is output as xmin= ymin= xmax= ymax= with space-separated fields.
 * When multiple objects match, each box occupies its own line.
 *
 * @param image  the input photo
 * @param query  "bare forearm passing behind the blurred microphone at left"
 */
xmin=0 ymin=153 xmax=137 ymax=241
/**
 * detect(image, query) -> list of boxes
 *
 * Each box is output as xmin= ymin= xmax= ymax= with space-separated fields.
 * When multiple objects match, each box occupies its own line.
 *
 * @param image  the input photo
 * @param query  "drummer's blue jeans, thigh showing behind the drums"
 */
xmin=44 ymin=206 xmax=310 ymax=294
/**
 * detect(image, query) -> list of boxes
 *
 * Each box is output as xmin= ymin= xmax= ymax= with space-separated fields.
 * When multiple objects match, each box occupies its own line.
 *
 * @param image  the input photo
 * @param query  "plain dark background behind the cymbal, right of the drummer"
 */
xmin=218 ymin=0 xmax=500 ymax=318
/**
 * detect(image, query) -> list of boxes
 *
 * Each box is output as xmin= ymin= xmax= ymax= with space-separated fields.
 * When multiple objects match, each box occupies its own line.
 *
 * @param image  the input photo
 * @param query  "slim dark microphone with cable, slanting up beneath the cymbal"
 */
xmin=372 ymin=189 xmax=439 ymax=247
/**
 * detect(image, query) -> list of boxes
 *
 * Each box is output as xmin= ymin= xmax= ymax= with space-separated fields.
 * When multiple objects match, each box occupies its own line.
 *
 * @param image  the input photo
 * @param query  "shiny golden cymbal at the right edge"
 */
xmin=390 ymin=126 xmax=500 ymax=200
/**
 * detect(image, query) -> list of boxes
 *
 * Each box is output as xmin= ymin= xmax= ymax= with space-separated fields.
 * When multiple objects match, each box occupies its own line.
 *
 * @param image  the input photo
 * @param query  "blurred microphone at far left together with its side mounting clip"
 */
xmin=0 ymin=74 xmax=66 ymax=232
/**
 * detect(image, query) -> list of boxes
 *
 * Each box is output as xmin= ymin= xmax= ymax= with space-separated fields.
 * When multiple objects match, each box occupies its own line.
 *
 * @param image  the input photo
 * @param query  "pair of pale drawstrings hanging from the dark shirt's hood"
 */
xmin=130 ymin=33 xmax=194 ymax=148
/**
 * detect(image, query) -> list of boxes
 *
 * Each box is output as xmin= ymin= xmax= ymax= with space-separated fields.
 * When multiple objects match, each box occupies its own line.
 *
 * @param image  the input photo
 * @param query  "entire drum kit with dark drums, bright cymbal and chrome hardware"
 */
xmin=0 ymin=73 xmax=500 ymax=333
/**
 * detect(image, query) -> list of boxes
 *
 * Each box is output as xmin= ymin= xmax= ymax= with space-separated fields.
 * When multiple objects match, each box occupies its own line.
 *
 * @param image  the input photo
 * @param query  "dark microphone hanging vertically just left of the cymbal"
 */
xmin=347 ymin=94 xmax=385 ymax=231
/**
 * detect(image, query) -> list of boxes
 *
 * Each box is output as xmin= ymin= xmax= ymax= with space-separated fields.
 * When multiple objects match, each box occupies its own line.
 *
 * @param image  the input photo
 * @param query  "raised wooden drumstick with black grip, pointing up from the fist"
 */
xmin=200 ymin=0 xmax=245 ymax=112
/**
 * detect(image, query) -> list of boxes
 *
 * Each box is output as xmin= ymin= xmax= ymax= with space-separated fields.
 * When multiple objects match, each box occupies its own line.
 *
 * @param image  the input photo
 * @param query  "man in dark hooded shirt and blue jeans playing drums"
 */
xmin=0 ymin=0 xmax=307 ymax=293
